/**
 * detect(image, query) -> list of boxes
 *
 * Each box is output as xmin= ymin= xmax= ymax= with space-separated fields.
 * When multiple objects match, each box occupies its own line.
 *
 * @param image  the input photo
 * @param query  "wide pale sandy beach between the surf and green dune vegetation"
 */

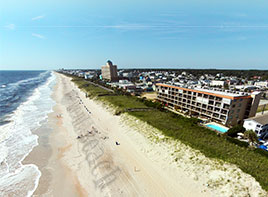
xmin=24 ymin=73 xmax=266 ymax=197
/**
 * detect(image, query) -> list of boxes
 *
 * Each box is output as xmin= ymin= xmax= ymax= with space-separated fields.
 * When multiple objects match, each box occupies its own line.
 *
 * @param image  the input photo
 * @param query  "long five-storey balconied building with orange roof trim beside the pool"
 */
xmin=156 ymin=83 xmax=261 ymax=126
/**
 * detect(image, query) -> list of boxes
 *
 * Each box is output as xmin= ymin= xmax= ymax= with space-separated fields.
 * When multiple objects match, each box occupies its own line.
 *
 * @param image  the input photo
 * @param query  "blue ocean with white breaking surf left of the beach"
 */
xmin=0 ymin=71 xmax=56 ymax=196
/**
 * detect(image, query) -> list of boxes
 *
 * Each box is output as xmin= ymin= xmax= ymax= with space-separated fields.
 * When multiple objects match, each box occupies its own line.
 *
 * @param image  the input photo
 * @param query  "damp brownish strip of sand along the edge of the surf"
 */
xmin=22 ymin=73 xmax=86 ymax=197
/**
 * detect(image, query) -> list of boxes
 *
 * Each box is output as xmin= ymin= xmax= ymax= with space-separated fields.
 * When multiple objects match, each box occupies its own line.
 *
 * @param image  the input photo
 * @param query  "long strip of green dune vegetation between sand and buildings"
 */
xmin=66 ymin=75 xmax=268 ymax=191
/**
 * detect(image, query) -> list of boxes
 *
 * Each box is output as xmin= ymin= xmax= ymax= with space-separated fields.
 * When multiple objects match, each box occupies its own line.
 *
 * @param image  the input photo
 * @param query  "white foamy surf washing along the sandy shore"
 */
xmin=0 ymin=71 xmax=55 ymax=196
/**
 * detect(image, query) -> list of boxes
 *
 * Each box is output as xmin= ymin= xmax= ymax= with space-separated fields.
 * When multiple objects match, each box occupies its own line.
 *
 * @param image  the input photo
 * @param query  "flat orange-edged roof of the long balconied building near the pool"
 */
xmin=156 ymin=83 xmax=255 ymax=100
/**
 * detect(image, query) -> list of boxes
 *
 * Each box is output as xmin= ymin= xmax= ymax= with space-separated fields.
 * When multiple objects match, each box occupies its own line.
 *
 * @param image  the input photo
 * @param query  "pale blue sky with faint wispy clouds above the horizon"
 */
xmin=0 ymin=0 xmax=268 ymax=70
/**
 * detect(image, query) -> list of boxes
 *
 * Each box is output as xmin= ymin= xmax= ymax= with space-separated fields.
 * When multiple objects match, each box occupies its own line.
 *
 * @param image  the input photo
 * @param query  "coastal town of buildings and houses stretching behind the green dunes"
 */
xmin=60 ymin=60 xmax=268 ymax=151
